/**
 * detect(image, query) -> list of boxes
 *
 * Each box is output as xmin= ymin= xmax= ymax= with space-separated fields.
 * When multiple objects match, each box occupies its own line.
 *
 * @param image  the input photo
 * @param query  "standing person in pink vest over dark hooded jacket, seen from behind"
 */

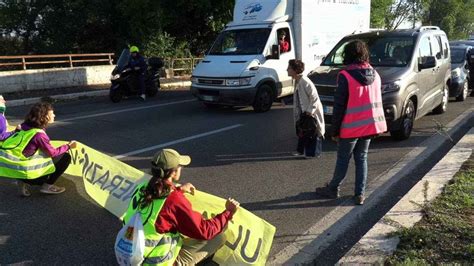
xmin=316 ymin=40 xmax=387 ymax=205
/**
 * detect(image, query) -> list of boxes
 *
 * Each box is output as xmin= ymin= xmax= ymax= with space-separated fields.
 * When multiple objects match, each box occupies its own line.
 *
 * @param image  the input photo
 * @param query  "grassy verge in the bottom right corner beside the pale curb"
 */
xmin=387 ymin=156 xmax=474 ymax=265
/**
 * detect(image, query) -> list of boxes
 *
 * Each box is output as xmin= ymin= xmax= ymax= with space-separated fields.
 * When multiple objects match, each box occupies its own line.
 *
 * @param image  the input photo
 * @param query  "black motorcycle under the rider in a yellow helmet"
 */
xmin=109 ymin=48 xmax=163 ymax=103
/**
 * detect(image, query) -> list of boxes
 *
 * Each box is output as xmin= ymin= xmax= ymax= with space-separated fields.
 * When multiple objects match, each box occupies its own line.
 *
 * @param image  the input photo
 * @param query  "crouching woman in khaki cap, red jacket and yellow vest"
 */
xmin=124 ymin=149 xmax=239 ymax=265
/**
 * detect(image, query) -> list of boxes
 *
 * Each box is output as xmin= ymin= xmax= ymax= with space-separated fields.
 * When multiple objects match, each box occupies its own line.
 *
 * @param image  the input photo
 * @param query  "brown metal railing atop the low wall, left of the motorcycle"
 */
xmin=0 ymin=53 xmax=114 ymax=70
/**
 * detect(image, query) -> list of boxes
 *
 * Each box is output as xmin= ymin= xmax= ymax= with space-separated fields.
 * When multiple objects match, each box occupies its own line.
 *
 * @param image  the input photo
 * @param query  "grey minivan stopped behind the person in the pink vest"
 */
xmin=308 ymin=26 xmax=451 ymax=140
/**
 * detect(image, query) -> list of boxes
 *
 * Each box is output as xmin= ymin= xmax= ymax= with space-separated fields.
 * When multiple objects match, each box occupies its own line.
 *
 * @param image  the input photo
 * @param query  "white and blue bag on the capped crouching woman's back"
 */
xmin=115 ymin=213 xmax=145 ymax=266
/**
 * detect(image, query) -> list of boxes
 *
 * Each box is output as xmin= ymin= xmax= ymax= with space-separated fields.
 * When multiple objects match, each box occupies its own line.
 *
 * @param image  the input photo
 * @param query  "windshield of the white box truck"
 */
xmin=209 ymin=29 xmax=270 ymax=55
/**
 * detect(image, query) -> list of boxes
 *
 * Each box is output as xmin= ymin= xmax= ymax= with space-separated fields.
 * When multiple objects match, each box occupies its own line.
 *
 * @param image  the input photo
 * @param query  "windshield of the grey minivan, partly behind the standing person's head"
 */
xmin=321 ymin=36 xmax=415 ymax=67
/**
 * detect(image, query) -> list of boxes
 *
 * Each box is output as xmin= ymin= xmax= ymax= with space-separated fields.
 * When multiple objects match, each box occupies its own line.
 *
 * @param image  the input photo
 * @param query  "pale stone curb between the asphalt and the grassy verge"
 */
xmin=337 ymin=128 xmax=474 ymax=265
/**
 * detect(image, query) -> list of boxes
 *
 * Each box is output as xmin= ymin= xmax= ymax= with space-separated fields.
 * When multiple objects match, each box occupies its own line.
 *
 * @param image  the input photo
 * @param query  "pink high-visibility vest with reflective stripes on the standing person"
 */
xmin=339 ymin=66 xmax=387 ymax=138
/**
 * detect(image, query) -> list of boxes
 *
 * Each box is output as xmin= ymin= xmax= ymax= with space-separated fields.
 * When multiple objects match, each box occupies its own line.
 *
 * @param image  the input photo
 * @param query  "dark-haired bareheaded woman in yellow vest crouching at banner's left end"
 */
xmin=0 ymin=102 xmax=77 ymax=197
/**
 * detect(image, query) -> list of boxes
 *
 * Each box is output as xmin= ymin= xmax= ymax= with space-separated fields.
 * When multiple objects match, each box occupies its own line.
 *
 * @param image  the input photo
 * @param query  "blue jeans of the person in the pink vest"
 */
xmin=329 ymin=138 xmax=370 ymax=196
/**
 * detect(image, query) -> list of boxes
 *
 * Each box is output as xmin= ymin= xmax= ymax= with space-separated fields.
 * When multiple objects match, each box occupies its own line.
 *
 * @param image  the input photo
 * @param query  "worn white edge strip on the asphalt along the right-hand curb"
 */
xmin=268 ymin=107 xmax=474 ymax=265
